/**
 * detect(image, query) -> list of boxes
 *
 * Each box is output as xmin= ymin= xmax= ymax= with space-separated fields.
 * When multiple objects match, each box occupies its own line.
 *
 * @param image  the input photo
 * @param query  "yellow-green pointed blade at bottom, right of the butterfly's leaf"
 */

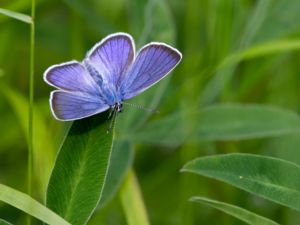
xmin=120 ymin=169 xmax=150 ymax=225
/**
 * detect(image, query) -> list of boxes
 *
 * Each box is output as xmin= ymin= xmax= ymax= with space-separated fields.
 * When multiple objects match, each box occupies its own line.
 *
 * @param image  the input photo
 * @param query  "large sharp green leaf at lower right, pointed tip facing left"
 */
xmin=182 ymin=153 xmax=300 ymax=211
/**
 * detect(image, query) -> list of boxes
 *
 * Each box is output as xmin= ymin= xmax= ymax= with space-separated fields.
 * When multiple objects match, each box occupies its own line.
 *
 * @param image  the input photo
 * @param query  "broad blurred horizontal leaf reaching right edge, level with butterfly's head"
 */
xmin=132 ymin=104 xmax=300 ymax=145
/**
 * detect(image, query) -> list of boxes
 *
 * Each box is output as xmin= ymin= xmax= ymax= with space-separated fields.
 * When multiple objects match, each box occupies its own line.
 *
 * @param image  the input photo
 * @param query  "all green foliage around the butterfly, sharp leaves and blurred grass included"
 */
xmin=0 ymin=0 xmax=300 ymax=225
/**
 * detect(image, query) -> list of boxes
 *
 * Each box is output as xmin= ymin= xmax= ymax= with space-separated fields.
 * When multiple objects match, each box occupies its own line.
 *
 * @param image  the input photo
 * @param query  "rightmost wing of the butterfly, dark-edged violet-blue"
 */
xmin=120 ymin=43 xmax=182 ymax=100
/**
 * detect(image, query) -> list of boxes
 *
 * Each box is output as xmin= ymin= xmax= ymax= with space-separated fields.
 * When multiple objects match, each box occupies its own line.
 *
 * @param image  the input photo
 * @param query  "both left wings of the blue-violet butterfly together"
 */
xmin=44 ymin=61 xmax=109 ymax=121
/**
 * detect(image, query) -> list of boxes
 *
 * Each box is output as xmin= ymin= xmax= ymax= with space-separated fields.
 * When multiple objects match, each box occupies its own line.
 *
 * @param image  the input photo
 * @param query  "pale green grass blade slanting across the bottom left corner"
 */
xmin=0 ymin=184 xmax=70 ymax=225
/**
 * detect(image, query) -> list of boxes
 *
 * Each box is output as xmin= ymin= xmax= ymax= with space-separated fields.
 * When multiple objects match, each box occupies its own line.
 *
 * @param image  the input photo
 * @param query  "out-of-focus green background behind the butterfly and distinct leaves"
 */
xmin=0 ymin=0 xmax=300 ymax=225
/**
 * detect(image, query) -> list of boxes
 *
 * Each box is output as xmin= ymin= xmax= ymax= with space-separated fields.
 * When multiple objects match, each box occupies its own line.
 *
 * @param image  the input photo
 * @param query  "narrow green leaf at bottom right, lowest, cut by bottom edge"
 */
xmin=190 ymin=197 xmax=279 ymax=225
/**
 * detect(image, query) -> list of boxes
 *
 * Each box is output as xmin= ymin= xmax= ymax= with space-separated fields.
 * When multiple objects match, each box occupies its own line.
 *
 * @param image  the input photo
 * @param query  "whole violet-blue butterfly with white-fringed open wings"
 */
xmin=44 ymin=33 xmax=182 ymax=121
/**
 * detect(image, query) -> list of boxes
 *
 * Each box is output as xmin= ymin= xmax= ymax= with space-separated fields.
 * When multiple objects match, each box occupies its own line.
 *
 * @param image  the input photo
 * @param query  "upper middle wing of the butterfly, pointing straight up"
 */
xmin=85 ymin=33 xmax=135 ymax=89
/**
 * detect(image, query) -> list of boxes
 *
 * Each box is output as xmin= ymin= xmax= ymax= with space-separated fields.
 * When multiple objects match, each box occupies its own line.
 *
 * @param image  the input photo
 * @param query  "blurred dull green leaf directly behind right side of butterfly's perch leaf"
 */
xmin=99 ymin=140 xmax=134 ymax=208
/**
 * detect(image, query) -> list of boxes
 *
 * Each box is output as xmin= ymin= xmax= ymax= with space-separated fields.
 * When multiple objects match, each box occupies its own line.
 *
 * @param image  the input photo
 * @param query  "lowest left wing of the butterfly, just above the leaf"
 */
xmin=50 ymin=90 xmax=109 ymax=121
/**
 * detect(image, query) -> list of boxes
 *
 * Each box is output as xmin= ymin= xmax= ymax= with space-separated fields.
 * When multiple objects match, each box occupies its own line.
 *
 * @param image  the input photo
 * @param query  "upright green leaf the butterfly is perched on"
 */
xmin=47 ymin=113 xmax=113 ymax=225
